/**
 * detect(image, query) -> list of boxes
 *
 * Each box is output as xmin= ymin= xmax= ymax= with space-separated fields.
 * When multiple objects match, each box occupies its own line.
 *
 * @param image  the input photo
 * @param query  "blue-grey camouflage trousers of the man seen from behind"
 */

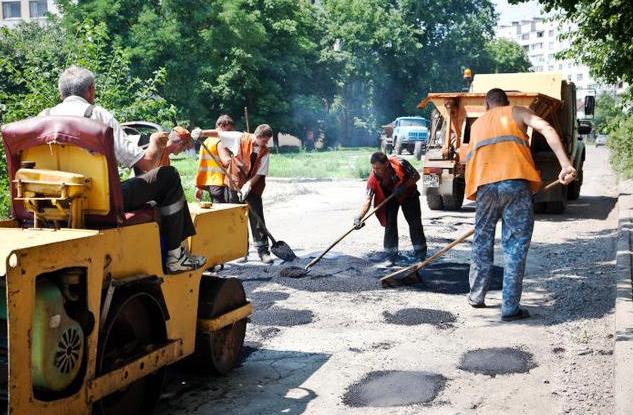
xmin=468 ymin=180 xmax=534 ymax=316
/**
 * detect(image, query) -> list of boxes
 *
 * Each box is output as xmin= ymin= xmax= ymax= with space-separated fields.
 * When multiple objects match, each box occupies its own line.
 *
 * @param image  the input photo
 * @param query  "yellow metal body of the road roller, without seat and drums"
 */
xmin=0 ymin=201 xmax=252 ymax=415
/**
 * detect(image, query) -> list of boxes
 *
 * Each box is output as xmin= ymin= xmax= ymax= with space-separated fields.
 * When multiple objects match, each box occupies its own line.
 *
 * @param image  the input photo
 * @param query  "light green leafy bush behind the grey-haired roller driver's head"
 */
xmin=0 ymin=19 xmax=176 ymax=216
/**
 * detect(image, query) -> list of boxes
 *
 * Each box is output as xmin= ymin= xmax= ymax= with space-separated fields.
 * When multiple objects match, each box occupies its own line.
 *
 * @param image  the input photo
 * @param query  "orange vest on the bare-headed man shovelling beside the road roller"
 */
xmin=225 ymin=133 xmax=268 ymax=195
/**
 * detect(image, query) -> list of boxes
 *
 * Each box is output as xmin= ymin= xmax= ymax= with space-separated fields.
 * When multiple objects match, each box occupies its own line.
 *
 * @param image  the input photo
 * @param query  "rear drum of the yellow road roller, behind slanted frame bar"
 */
xmin=93 ymin=290 xmax=167 ymax=415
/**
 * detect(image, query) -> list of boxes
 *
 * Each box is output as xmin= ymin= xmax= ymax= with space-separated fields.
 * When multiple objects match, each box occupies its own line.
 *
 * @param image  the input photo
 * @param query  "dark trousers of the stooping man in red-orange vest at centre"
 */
xmin=384 ymin=190 xmax=426 ymax=256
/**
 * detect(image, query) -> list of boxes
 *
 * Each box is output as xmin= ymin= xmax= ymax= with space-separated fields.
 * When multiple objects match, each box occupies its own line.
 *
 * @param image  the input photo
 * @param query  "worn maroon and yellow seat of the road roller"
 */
xmin=2 ymin=116 xmax=156 ymax=229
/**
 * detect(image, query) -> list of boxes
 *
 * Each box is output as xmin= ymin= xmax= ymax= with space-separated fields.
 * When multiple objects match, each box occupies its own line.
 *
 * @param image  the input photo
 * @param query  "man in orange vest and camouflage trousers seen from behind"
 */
xmin=465 ymin=88 xmax=576 ymax=321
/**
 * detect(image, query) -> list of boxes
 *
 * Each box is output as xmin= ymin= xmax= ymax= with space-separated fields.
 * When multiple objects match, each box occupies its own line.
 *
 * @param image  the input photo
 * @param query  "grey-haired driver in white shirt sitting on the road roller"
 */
xmin=40 ymin=66 xmax=206 ymax=273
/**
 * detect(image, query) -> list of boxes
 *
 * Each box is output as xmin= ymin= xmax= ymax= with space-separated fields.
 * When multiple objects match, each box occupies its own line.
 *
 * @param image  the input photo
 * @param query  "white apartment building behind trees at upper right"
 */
xmin=496 ymin=17 xmax=624 ymax=98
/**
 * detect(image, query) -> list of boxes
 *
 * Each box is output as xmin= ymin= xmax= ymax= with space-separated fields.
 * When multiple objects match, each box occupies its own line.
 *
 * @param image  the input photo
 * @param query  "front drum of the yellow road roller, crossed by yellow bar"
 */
xmin=191 ymin=277 xmax=246 ymax=375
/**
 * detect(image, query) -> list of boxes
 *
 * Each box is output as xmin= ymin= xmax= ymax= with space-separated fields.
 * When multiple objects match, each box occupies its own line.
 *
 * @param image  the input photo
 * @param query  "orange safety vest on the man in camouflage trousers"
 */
xmin=465 ymin=106 xmax=541 ymax=200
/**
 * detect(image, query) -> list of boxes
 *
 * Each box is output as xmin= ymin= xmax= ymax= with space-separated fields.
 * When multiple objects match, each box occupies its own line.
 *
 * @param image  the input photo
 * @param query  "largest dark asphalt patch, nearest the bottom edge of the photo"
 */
xmin=343 ymin=370 xmax=446 ymax=408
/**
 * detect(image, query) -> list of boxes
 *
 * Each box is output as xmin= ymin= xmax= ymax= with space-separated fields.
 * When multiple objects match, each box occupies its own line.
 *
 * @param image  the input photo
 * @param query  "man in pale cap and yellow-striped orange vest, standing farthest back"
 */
xmin=196 ymin=115 xmax=235 ymax=203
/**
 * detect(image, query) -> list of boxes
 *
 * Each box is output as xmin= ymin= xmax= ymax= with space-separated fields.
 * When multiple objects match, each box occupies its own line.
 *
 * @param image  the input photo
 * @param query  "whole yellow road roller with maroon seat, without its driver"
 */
xmin=0 ymin=116 xmax=252 ymax=415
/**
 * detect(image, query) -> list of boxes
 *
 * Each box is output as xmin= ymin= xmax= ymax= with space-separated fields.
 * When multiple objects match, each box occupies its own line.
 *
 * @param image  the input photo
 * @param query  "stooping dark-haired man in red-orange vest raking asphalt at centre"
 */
xmin=354 ymin=152 xmax=427 ymax=264
